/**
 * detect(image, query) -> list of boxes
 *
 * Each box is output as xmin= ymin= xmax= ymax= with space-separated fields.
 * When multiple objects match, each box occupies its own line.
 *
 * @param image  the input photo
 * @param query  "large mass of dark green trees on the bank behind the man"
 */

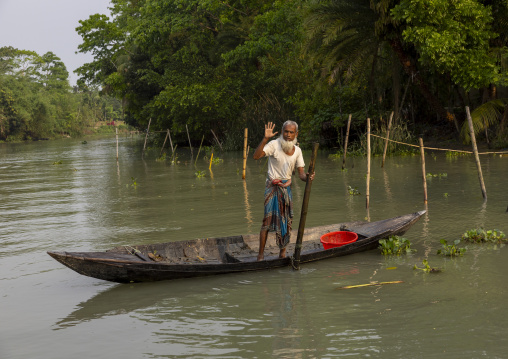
xmin=2 ymin=0 xmax=508 ymax=152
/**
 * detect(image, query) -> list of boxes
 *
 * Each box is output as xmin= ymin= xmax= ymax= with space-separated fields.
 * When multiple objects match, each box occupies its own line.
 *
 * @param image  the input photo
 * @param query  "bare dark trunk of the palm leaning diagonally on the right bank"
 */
xmin=390 ymin=39 xmax=453 ymax=120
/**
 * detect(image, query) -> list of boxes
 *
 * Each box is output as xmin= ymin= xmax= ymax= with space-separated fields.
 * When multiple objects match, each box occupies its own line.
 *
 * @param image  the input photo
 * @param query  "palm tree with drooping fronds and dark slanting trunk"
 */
xmin=305 ymin=0 xmax=453 ymax=119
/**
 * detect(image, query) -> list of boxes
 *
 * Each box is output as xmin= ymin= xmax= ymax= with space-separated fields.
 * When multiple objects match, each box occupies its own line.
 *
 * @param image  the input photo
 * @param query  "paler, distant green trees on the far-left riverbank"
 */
xmin=0 ymin=47 xmax=122 ymax=141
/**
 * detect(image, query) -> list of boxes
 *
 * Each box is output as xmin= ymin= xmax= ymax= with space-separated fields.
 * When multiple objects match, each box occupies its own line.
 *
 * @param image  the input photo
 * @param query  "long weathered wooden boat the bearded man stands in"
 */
xmin=48 ymin=211 xmax=425 ymax=283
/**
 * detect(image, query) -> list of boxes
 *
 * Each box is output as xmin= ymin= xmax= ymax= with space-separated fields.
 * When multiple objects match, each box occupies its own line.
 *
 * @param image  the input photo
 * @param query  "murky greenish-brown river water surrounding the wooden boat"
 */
xmin=0 ymin=137 xmax=508 ymax=359
